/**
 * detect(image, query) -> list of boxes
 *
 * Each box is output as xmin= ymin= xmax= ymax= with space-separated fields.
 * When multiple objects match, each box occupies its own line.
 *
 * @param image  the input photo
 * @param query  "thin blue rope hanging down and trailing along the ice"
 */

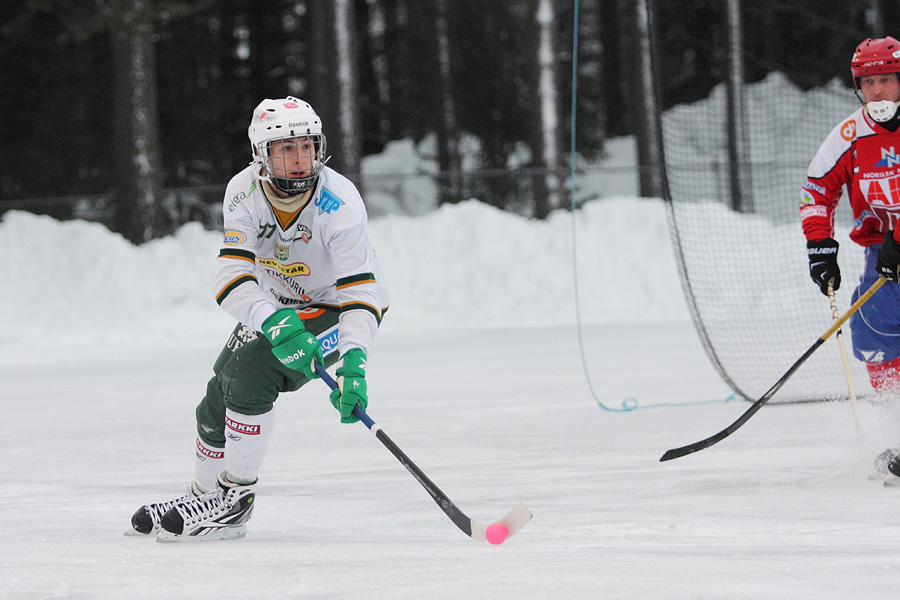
xmin=569 ymin=0 xmax=737 ymax=412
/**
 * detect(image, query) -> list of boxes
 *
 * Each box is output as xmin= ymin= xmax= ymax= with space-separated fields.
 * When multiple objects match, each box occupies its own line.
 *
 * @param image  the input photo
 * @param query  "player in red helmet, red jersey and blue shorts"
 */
xmin=800 ymin=37 xmax=900 ymax=484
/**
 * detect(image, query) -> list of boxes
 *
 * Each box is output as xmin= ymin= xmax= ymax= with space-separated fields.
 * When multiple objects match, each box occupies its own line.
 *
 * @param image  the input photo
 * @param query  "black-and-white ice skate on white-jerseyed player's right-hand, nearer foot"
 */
xmin=156 ymin=474 xmax=256 ymax=542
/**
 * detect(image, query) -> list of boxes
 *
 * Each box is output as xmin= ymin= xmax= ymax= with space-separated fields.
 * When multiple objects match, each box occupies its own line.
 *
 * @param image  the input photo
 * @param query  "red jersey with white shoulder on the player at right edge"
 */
xmin=800 ymin=107 xmax=900 ymax=246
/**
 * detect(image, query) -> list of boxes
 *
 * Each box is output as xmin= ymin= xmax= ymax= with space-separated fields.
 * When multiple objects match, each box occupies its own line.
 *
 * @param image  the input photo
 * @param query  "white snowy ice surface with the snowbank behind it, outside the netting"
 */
xmin=0 ymin=197 xmax=900 ymax=600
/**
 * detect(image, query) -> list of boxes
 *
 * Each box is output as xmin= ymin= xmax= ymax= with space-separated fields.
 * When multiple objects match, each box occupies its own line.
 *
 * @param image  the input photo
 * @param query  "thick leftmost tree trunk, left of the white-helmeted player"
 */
xmin=111 ymin=0 xmax=163 ymax=244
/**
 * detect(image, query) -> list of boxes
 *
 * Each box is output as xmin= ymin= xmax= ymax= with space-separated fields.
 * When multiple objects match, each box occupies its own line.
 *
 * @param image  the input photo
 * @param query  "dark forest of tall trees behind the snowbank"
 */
xmin=0 ymin=0 xmax=900 ymax=243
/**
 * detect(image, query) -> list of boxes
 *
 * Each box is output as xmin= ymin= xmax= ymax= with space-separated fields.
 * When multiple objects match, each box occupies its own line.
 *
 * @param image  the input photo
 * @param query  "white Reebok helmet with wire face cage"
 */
xmin=247 ymin=96 xmax=325 ymax=194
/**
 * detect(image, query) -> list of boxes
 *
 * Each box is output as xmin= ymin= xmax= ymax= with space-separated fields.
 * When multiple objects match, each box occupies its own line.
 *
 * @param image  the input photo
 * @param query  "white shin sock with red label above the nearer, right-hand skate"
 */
xmin=225 ymin=409 xmax=275 ymax=483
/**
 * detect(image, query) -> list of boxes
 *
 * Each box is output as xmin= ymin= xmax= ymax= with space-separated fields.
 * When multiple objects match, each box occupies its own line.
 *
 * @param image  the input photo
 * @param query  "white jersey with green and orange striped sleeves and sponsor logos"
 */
xmin=216 ymin=164 xmax=390 ymax=356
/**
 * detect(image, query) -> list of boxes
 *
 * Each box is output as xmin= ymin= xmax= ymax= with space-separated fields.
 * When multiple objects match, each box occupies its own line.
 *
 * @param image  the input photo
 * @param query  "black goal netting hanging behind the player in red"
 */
xmin=662 ymin=74 xmax=871 ymax=402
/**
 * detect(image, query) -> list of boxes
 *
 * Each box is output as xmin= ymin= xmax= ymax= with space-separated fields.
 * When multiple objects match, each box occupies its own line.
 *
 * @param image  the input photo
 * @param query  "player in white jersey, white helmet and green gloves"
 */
xmin=132 ymin=97 xmax=389 ymax=541
